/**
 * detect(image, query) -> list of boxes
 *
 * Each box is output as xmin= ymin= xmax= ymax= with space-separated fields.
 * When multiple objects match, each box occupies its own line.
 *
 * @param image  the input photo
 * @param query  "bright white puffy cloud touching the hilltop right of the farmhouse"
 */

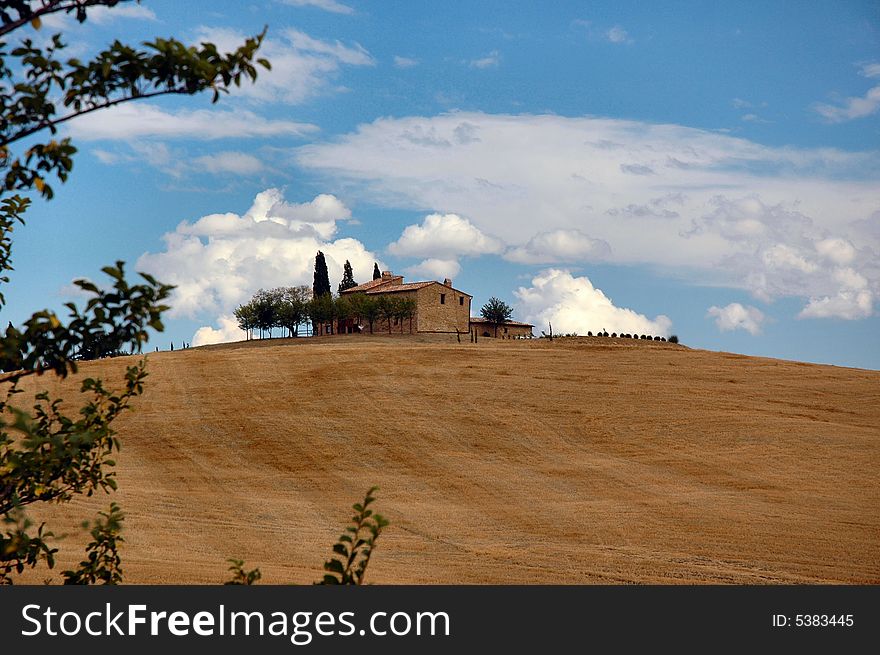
xmin=514 ymin=269 xmax=672 ymax=336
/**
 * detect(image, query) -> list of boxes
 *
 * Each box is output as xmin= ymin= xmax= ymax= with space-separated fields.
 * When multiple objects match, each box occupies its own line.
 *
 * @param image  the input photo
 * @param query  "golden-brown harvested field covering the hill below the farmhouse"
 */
xmin=13 ymin=336 xmax=880 ymax=584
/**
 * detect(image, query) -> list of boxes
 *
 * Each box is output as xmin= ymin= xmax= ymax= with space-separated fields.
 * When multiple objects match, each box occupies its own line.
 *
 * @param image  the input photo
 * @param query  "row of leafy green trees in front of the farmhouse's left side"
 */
xmin=234 ymin=286 xmax=416 ymax=339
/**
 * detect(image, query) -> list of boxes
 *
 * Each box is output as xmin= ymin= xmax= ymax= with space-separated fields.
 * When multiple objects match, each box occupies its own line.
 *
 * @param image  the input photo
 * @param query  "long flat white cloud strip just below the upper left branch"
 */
xmin=70 ymin=103 xmax=318 ymax=141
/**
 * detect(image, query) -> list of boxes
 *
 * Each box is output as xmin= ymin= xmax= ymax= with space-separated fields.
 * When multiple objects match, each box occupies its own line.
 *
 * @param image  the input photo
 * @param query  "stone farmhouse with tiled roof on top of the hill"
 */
xmin=337 ymin=271 xmax=532 ymax=338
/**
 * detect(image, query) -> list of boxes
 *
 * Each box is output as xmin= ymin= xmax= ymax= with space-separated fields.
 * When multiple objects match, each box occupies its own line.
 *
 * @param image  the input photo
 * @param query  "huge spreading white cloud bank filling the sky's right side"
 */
xmin=296 ymin=112 xmax=880 ymax=316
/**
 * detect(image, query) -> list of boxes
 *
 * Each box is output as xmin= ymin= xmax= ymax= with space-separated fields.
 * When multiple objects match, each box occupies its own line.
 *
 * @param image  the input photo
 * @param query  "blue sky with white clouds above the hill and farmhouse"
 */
xmin=5 ymin=0 xmax=880 ymax=369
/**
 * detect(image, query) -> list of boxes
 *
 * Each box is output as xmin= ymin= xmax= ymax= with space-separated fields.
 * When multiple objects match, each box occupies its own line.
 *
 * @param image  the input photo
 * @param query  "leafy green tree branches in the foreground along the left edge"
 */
xmin=0 ymin=0 xmax=269 ymax=583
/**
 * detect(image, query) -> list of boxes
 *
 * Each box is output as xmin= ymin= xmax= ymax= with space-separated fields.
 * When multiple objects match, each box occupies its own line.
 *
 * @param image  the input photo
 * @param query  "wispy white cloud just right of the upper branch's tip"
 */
xmin=196 ymin=27 xmax=376 ymax=105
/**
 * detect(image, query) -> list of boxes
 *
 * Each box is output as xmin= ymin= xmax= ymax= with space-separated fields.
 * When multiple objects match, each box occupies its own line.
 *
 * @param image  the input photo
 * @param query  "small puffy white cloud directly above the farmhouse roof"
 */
xmin=388 ymin=214 xmax=503 ymax=259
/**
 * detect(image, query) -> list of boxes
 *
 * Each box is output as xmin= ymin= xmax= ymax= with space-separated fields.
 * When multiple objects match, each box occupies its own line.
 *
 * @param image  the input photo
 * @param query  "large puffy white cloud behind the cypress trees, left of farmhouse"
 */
xmin=138 ymin=189 xmax=381 ymax=343
